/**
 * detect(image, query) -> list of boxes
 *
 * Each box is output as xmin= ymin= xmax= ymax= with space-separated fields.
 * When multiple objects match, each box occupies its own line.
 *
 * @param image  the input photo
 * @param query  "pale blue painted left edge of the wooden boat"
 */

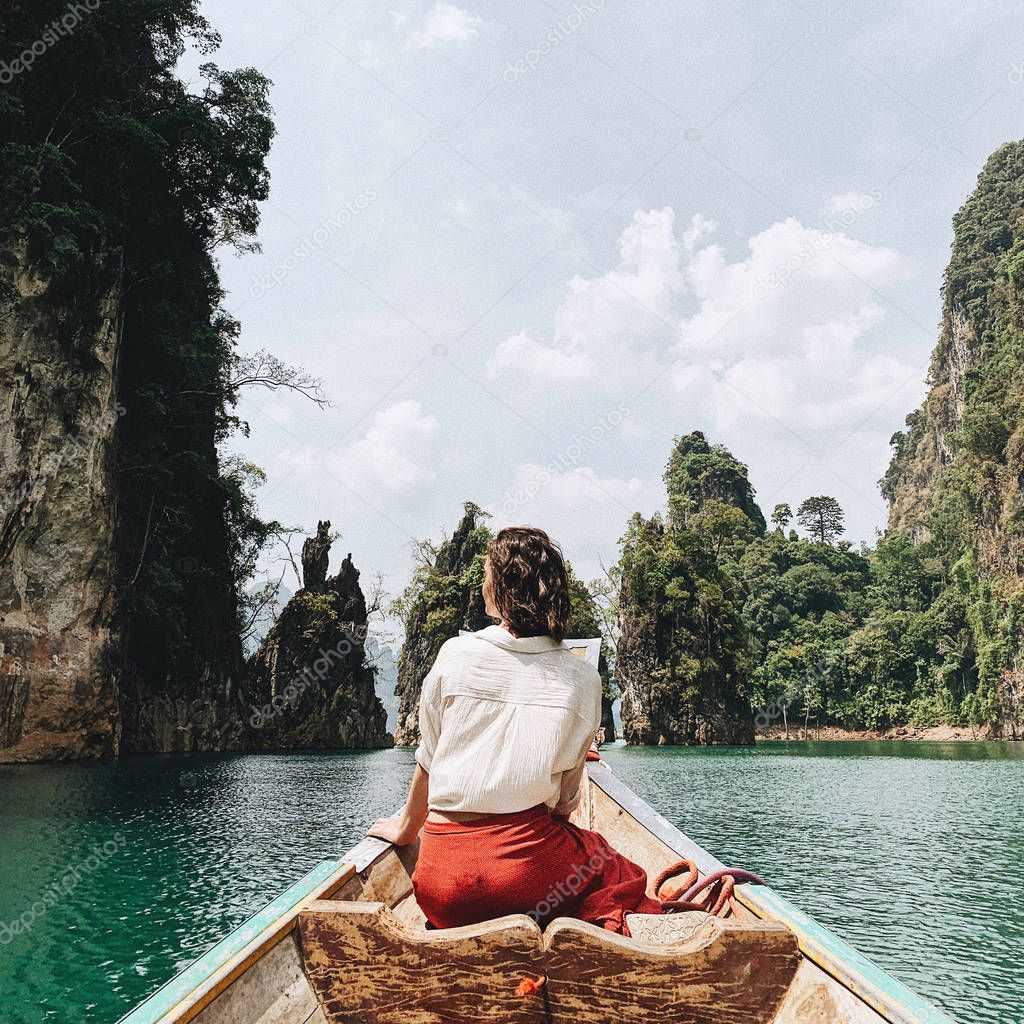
xmin=118 ymin=860 xmax=349 ymax=1024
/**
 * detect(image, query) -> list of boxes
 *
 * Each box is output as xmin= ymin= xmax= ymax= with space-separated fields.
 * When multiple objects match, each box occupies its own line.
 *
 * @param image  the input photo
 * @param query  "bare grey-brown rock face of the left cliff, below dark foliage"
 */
xmin=0 ymin=245 xmax=124 ymax=761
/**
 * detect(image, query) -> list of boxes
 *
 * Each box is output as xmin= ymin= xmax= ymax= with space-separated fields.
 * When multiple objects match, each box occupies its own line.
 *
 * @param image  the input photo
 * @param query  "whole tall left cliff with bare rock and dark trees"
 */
xmin=0 ymin=0 xmax=273 ymax=761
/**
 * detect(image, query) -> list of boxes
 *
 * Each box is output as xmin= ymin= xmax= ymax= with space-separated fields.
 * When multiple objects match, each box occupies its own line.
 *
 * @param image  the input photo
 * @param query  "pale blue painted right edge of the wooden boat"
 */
xmin=588 ymin=763 xmax=955 ymax=1024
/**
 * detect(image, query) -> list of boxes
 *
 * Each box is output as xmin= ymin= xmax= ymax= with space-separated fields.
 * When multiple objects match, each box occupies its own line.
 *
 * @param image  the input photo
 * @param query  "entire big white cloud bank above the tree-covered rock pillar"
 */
xmin=487 ymin=203 xmax=915 ymax=443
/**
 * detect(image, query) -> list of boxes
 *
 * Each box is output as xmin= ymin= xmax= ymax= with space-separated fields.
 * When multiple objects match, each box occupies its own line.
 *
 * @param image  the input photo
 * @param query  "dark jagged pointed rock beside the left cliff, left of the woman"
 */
xmin=248 ymin=522 xmax=392 ymax=750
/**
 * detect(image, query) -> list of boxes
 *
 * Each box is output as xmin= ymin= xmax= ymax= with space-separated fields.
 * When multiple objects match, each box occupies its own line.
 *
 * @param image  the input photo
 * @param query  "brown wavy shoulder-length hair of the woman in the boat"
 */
xmin=487 ymin=526 xmax=570 ymax=642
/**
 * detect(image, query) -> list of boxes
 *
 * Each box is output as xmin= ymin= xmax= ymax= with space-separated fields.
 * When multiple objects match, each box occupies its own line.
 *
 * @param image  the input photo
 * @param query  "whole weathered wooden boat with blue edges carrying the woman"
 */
xmin=116 ymin=763 xmax=952 ymax=1024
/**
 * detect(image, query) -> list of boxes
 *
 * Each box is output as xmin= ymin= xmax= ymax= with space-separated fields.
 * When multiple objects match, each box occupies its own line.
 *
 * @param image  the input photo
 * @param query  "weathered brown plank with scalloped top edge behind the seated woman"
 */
xmin=299 ymin=901 xmax=800 ymax=1024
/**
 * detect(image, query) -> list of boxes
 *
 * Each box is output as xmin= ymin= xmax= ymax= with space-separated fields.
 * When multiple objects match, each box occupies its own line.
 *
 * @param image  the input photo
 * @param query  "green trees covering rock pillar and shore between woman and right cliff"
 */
xmin=614 ymin=421 xmax=1007 ymax=743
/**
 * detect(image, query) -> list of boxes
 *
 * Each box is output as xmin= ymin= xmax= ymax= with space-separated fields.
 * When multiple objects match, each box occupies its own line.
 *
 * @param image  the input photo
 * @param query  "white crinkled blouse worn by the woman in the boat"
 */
xmin=416 ymin=626 xmax=601 ymax=814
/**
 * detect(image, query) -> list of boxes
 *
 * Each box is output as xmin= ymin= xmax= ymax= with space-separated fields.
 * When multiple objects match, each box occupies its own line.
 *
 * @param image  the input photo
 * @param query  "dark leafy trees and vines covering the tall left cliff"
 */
xmin=0 ymin=0 xmax=273 ymax=749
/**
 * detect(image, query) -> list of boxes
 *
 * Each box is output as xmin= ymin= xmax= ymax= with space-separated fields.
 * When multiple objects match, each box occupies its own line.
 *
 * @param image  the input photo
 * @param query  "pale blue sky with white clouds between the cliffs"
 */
xmin=183 ymin=0 xmax=1024 ymax=630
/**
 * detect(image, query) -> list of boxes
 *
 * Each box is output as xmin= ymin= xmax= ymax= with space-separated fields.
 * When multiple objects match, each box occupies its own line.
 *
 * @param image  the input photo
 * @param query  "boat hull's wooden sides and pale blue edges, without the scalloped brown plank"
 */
xmin=121 ymin=764 xmax=952 ymax=1024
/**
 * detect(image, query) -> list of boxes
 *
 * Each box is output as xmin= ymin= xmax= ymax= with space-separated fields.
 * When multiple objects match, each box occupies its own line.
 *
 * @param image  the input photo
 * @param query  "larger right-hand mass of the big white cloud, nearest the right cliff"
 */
xmin=674 ymin=211 xmax=914 ymax=430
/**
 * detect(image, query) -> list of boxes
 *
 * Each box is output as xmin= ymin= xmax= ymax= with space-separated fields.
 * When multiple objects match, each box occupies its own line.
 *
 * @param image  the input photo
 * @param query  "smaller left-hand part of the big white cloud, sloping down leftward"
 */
xmin=487 ymin=207 xmax=684 ymax=383
